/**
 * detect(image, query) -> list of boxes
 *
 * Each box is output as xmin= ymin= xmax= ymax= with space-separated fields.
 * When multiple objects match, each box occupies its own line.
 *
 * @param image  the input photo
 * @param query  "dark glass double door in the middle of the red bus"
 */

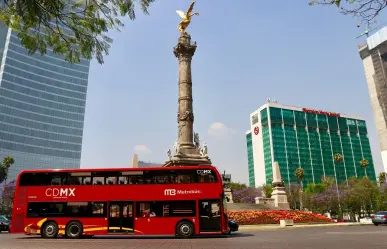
xmin=108 ymin=201 xmax=134 ymax=233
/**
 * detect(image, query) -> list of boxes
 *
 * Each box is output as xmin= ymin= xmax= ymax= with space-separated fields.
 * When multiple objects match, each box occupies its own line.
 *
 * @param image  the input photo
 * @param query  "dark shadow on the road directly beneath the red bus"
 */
xmin=15 ymin=233 xmax=254 ymax=241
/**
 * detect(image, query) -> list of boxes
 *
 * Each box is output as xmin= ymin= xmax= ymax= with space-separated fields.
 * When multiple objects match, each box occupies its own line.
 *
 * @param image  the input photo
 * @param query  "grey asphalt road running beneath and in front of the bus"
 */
xmin=0 ymin=225 xmax=387 ymax=249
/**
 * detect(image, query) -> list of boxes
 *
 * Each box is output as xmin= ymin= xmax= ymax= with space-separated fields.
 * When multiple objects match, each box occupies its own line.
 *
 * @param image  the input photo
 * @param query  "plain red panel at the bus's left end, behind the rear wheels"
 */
xmin=11 ymin=186 xmax=27 ymax=233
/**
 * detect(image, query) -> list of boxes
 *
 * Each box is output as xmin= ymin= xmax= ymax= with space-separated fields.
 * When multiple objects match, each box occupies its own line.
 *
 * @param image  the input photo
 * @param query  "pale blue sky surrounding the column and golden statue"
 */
xmin=81 ymin=0 xmax=386 ymax=183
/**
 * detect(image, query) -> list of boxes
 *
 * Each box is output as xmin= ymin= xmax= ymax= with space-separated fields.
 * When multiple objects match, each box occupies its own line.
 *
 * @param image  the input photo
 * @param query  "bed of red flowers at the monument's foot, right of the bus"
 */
xmin=227 ymin=210 xmax=332 ymax=225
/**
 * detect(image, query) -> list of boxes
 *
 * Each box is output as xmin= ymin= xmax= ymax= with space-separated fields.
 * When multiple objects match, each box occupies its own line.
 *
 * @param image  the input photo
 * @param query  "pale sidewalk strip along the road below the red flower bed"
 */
xmin=239 ymin=222 xmax=372 ymax=231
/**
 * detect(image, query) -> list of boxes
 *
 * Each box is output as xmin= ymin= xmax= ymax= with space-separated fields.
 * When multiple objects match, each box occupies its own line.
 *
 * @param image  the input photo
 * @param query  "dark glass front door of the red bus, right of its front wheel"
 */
xmin=199 ymin=199 xmax=222 ymax=232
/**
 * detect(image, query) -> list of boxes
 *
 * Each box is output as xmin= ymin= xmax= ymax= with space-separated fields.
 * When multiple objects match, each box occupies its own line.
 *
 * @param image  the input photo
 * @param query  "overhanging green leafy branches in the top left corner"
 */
xmin=0 ymin=0 xmax=154 ymax=64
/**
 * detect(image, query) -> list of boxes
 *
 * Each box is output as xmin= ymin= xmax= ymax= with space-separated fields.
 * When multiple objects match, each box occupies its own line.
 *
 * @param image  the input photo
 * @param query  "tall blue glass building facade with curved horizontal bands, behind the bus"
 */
xmin=0 ymin=25 xmax=90 ymax=180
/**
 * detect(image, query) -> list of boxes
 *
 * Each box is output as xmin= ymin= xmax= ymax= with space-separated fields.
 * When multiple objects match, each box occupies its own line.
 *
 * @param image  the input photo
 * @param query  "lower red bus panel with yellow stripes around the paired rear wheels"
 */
xmin=24 ymin=217 xmax=108 ymax=235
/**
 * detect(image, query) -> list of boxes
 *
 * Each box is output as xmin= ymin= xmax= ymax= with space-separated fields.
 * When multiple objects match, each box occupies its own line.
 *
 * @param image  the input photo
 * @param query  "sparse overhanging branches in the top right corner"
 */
xmin=309 ymin=0 xmax=387 ymax=24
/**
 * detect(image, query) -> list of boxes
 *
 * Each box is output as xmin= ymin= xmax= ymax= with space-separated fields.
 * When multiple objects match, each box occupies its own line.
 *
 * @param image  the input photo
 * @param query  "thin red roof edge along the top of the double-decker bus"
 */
xmin=19 ymin=165 xmax=217 ymax=175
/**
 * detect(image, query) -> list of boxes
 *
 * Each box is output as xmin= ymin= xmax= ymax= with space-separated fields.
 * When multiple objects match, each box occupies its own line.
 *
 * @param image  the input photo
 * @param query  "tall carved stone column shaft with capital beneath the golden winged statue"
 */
xmin=173 ymin=34 xmax=196 ymax=152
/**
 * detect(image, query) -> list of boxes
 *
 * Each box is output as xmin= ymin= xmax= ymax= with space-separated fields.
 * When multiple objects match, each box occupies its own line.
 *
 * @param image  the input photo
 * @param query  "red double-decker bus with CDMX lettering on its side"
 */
xmin=11 ymin=166 xmax=229 ymax=238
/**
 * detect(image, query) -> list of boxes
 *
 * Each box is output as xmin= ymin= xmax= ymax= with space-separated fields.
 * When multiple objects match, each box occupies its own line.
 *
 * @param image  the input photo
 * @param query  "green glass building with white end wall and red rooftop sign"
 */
xmin=246 ymin=103 xmax=376 ymax=186
